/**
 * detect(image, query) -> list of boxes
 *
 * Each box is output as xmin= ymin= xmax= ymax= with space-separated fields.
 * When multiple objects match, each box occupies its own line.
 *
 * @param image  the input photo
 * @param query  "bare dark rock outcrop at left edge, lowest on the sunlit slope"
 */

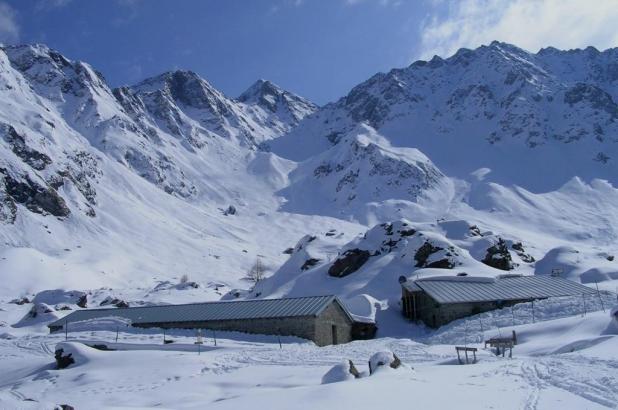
xmin=0 ymin=168 xmax=71 ymax=218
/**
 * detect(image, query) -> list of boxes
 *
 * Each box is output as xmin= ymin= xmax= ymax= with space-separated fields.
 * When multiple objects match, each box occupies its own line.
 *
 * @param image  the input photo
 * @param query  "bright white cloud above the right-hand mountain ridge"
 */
xmin=417 ymin=0 xmax=618 ymax=59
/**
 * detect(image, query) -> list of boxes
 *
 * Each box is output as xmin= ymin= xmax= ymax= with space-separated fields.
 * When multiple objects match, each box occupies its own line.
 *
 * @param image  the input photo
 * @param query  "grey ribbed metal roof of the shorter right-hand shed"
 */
xmin=403 ymin=275 xmax=596 ymax=303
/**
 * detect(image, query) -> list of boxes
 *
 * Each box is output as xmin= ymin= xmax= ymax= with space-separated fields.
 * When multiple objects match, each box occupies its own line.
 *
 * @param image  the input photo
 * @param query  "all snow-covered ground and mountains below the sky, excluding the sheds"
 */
xmin=0 ymin=42 xmax=618 ymax=409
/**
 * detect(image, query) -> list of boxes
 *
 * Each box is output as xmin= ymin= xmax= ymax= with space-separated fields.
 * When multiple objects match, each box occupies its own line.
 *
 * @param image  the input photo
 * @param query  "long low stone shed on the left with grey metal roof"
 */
xmin=48 ymin=295 xmax=364 ymax=346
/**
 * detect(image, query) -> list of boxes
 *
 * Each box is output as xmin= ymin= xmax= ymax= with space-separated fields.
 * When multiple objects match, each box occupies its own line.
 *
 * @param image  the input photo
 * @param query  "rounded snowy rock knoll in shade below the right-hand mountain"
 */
xmin=280 ymin=125 xmax=452 ymax=224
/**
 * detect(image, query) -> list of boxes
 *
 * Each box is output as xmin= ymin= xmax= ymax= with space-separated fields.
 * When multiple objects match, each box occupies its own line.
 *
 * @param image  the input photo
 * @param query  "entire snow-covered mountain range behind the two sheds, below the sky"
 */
xmin=0 ymin=43 xmax=618 ymax=308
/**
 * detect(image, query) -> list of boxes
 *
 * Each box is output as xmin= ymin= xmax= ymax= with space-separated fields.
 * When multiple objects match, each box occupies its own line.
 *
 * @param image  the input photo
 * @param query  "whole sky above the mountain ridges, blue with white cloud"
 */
xmin=0 ymin=0 xmax=618 ymax=104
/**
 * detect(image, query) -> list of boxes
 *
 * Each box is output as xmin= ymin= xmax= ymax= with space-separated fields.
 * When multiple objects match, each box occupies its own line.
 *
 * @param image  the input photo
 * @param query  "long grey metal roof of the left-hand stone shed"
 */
xmin=48 ymin=296 xmax=349 ymax=327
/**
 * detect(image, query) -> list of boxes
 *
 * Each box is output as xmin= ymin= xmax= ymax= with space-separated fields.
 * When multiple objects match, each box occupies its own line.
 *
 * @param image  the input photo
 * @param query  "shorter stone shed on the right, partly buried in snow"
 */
xmin=401 ymin=275 xmax=596 ymax=328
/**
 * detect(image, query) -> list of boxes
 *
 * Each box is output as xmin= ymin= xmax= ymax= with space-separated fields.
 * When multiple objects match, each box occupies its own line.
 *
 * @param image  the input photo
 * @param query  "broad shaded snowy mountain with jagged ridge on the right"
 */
xmin=270 ymin=42 xmax=618 ymax=191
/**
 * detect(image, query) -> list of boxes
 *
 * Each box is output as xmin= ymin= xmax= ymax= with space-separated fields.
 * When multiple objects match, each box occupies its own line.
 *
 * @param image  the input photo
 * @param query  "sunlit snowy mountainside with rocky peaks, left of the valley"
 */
xmin=0 ymin=45 xmax=352 ymax=300
